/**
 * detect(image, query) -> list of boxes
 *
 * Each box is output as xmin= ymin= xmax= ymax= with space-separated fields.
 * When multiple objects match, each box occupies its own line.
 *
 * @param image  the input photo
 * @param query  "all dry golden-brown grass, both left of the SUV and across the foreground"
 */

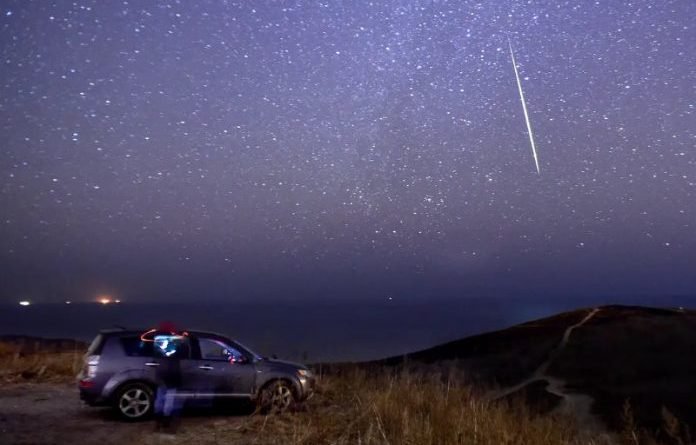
xmin=0 ymin=343 xmax=692 ymax=445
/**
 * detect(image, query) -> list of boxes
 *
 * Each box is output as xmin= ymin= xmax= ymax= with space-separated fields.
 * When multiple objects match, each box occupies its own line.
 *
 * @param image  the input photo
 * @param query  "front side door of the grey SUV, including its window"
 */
xmin=187 ymin=336 xmax=255 ymax=398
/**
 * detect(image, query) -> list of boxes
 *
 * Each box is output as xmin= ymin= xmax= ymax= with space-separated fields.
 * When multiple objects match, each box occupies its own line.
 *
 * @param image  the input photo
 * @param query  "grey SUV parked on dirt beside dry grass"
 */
xmin=78 ymin=329 xmax=315 ymax=420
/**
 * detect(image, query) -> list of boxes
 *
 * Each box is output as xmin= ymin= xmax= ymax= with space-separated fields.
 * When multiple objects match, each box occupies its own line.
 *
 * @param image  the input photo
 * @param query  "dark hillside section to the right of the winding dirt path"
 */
xmin=549 ymin=306 xmax=696 ymax=431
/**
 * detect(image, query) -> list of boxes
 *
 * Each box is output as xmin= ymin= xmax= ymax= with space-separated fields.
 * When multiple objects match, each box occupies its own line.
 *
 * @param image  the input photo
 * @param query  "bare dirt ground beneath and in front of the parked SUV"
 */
xmin=0 ymin=383 xmax=265 ymax=445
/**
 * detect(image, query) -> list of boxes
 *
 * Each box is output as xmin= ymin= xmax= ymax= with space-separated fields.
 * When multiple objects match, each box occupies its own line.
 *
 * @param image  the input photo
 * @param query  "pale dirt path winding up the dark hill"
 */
xmin=489 ymin=308 xmax=606 ymax=432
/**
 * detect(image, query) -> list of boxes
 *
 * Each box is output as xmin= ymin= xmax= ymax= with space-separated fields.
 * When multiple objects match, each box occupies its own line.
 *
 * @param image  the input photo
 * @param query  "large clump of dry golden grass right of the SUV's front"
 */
xmin=159 ymin=369 xmax=612 ymax=445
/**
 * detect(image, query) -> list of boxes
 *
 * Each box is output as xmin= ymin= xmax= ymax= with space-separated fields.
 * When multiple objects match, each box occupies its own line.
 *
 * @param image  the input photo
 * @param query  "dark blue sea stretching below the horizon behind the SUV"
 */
xmin=0 ymin=296 xmax=696 ymax=363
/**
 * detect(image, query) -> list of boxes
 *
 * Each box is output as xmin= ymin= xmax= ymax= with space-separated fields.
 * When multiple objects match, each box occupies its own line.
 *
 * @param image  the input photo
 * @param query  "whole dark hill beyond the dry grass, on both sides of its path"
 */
xmin=375 ymin=306 xmax=696 ymax=443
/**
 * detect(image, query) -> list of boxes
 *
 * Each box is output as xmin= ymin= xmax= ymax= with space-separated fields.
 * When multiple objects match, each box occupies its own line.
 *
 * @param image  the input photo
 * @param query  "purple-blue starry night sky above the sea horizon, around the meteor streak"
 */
xmin=0 ymin=0 xmax=696 ymax=304
